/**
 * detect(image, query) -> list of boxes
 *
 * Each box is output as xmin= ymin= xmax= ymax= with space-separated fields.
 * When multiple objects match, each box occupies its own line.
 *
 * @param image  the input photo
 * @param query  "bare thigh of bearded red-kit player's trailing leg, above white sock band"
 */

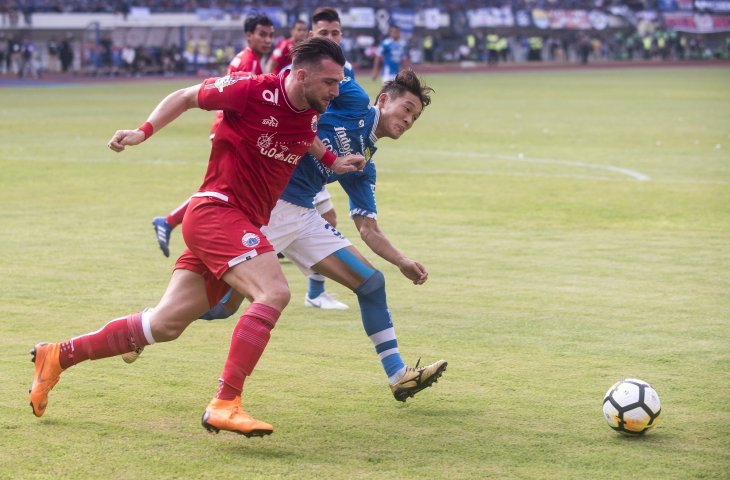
xmin=150 ymin=269 xmax=210 ymax=342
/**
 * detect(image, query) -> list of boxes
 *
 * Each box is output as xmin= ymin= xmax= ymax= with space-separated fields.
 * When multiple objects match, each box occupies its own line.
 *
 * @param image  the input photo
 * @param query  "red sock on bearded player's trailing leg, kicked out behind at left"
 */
xmin=61 ymin=312 xmax=149 ymax=368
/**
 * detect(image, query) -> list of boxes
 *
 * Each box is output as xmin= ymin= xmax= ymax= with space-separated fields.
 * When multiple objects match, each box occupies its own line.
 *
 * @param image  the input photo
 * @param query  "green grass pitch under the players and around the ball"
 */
xmin=0 ymin=68 xmax=730 ymax=479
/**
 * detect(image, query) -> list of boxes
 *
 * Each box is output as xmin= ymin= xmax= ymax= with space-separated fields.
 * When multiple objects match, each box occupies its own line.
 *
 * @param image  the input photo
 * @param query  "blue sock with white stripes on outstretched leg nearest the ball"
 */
xmin=355 ymin=270 xmax=406 ymax=383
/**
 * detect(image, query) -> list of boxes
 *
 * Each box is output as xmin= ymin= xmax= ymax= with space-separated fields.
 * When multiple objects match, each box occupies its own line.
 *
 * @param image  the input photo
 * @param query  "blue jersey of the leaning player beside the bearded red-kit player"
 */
xmin=280 ymin=78 xmax=380 ymax=218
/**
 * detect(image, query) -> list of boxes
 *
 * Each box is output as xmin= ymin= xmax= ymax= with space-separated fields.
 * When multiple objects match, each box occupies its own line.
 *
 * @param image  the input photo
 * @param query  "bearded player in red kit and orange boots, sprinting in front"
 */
xmin=30 ymin=38 xmax=364 ymax=436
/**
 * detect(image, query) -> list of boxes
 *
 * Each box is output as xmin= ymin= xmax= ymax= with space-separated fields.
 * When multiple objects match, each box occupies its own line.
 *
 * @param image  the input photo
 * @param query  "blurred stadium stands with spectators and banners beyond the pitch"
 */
xmin=0 ymin=0 xmax=730 ymax=78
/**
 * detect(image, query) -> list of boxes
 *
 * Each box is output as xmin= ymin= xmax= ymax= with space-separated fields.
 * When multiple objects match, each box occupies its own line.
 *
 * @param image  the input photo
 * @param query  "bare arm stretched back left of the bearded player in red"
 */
xmin=107 ymin=85 xmax=200 ymax=152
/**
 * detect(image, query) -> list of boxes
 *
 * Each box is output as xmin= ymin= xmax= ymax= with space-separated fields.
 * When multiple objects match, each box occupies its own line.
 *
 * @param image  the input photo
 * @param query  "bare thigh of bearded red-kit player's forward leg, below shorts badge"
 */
xmin=223 ymin=251 xmax=290 ymax=311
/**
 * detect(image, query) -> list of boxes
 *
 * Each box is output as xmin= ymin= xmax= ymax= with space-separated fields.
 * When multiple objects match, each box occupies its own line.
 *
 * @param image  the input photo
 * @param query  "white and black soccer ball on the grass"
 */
xmin=603 ymin=378 xmax=662 ymax=435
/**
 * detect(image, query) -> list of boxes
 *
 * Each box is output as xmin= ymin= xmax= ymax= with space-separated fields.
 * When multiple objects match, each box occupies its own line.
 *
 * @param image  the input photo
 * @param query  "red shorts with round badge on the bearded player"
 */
xmin=175 ymin=197 xmax=274 ymax=306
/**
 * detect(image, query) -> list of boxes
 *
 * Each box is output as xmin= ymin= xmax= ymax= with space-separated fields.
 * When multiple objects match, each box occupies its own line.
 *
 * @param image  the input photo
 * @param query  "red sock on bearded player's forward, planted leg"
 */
xmin=216 ymin=303 xmax=281 ymax=400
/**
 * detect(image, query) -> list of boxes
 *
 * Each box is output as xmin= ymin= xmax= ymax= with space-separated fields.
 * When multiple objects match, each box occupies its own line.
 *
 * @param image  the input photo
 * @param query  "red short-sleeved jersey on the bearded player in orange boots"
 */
xmin=194 ymin=72 xmax=319 ymax=226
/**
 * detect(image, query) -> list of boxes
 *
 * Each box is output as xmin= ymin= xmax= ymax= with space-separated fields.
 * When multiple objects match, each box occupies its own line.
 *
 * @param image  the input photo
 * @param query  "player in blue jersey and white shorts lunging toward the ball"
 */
xmin=127 ymin=70 xmax=447 ymax=401
